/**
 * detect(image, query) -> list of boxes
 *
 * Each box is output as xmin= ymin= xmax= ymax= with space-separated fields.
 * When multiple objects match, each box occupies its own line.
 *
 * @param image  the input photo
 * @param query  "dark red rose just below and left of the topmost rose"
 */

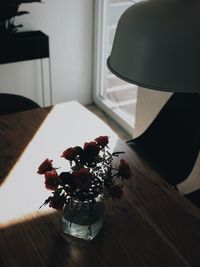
xmin=81 ymin=142 xmax=101 ymax=163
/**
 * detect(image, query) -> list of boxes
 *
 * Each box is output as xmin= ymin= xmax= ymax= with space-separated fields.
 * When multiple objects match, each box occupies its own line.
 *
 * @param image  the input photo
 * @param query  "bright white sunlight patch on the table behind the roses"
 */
xmin=0 ymin=102 xmax=117 ymax=224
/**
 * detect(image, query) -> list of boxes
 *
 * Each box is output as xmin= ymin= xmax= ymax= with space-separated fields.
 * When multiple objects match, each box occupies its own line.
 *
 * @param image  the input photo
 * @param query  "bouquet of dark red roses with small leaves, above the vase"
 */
xmin=38 ymin=136 xmax=131 ymax=210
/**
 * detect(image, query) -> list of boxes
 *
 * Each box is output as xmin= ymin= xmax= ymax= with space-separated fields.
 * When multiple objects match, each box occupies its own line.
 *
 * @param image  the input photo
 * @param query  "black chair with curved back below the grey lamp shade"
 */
xmin=127 ymin=93 xmax=200 ymax=207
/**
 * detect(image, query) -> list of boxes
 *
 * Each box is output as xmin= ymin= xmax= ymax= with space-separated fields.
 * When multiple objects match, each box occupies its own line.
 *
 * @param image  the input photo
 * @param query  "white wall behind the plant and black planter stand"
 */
xmin=0 ymin=0 xmax=93 ymax=107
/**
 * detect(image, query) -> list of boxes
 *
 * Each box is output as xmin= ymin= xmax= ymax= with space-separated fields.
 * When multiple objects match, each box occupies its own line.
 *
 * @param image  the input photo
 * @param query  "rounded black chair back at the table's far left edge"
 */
xmin=0 ymin=93 xmax=40 ymax=115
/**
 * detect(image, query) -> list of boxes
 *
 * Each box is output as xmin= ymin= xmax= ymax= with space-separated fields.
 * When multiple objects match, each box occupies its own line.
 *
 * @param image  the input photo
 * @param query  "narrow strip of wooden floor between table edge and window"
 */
xmin=86 ymin=104 xmax=131 ymax=141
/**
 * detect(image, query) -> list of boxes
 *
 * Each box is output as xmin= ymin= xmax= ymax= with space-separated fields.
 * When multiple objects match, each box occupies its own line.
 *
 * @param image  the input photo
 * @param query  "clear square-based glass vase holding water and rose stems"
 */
xmin=61 ymin=198 xmax=104 ymax=240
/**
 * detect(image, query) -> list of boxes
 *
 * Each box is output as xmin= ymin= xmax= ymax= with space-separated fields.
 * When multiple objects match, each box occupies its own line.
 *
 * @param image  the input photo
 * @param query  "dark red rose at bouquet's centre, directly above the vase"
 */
xmin=73 ymin=168 xmax=92 ymax=189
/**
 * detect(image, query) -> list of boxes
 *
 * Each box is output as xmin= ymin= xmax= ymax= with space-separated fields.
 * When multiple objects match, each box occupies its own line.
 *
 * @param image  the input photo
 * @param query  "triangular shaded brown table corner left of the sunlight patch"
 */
xmin=0 ymin=107 xmax=51 ymax=184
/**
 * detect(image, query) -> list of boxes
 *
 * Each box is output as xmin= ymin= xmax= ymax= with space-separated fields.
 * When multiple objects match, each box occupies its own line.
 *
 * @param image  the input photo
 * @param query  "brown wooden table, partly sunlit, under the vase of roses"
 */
xmin=0 ymin=102 xmax=200 ymax=267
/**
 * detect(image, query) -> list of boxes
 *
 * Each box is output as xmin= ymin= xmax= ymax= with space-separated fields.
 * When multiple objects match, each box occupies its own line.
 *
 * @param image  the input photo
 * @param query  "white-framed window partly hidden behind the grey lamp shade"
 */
xmin=94 ymin=0 xmax=137 ymax=136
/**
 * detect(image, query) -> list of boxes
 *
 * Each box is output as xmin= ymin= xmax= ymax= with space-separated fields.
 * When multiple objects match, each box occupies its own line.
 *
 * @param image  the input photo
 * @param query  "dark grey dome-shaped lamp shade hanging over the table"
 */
xmin=107 ymin=0 xmax=200 ymax=92
